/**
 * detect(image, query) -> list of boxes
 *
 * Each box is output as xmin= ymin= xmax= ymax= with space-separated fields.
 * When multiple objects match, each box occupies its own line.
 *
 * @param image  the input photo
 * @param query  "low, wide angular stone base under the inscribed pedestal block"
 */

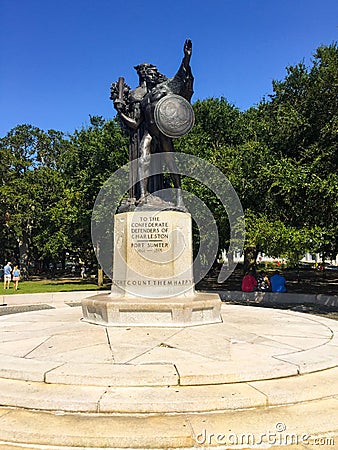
xmin=82 ymin=292 xmax=222 ymax=327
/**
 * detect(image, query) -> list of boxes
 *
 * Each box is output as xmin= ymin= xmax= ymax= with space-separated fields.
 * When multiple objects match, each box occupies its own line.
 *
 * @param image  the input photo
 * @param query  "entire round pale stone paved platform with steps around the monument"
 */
xmin=0 ymin=292 xmax=338 ymax=450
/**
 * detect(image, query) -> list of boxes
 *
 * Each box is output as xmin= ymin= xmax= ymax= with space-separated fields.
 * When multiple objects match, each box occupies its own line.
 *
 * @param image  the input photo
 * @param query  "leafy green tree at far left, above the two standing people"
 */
xmin=0 ymin=125 xmax=72 ymax=276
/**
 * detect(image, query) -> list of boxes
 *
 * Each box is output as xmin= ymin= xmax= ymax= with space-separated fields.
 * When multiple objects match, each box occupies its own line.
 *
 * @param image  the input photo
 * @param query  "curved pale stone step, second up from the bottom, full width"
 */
xmin=0 ymin=367 xmax=338 ymax=414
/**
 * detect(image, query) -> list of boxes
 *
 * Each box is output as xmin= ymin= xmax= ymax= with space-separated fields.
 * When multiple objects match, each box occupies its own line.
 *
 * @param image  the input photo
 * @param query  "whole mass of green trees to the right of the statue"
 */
xmin=177 ymin=45 xmax=338 ymax=266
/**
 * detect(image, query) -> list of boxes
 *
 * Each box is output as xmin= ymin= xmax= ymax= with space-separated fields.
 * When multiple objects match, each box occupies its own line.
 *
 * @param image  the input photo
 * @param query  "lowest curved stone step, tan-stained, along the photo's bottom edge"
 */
xmin=0 ymin=397 xmax=338 ymax=450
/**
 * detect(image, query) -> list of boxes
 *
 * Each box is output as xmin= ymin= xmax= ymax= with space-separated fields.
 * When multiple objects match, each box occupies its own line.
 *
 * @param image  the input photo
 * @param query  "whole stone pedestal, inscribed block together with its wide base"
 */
xmin=82 ymin=211 xmax=221 ymax=327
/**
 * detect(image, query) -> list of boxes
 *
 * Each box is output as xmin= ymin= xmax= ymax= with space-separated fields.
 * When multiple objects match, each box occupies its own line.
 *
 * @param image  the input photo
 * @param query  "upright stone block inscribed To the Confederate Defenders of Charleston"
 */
xmin=111 ymin=211 xmax=194 ymax=299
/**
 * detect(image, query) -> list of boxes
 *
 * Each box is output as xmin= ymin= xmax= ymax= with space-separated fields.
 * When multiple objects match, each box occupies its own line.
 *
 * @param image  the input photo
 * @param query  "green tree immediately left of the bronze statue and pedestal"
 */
xmin=59 ymin=116 xmax=128 ymax=278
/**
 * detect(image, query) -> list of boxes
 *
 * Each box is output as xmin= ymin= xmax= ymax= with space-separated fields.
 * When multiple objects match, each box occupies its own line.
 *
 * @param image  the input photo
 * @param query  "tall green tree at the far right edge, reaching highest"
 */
xmin=260 ymin=44 xmax=338 ymax=262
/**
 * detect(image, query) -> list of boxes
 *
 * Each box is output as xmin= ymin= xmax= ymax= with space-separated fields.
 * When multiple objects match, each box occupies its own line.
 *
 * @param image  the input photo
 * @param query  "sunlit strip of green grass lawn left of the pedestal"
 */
xmin=0 ymin=280 xmax=110 ymax=295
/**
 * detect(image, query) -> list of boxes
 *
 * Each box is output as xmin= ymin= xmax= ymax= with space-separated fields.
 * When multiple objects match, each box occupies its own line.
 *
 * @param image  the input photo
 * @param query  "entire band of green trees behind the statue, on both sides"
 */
xmin=0 ymin=44 xmax=338 ymax=272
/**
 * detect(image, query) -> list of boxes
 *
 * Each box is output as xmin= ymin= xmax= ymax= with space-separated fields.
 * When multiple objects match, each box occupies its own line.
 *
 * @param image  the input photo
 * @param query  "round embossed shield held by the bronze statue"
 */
xmin=154 ymin=94 xmax=195 ymax=138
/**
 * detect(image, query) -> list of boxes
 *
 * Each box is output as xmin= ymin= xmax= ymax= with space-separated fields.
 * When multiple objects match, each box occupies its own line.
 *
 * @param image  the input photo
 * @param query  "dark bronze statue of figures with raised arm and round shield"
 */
xmin=110 ymin=40 xmax=194 ymax=209
